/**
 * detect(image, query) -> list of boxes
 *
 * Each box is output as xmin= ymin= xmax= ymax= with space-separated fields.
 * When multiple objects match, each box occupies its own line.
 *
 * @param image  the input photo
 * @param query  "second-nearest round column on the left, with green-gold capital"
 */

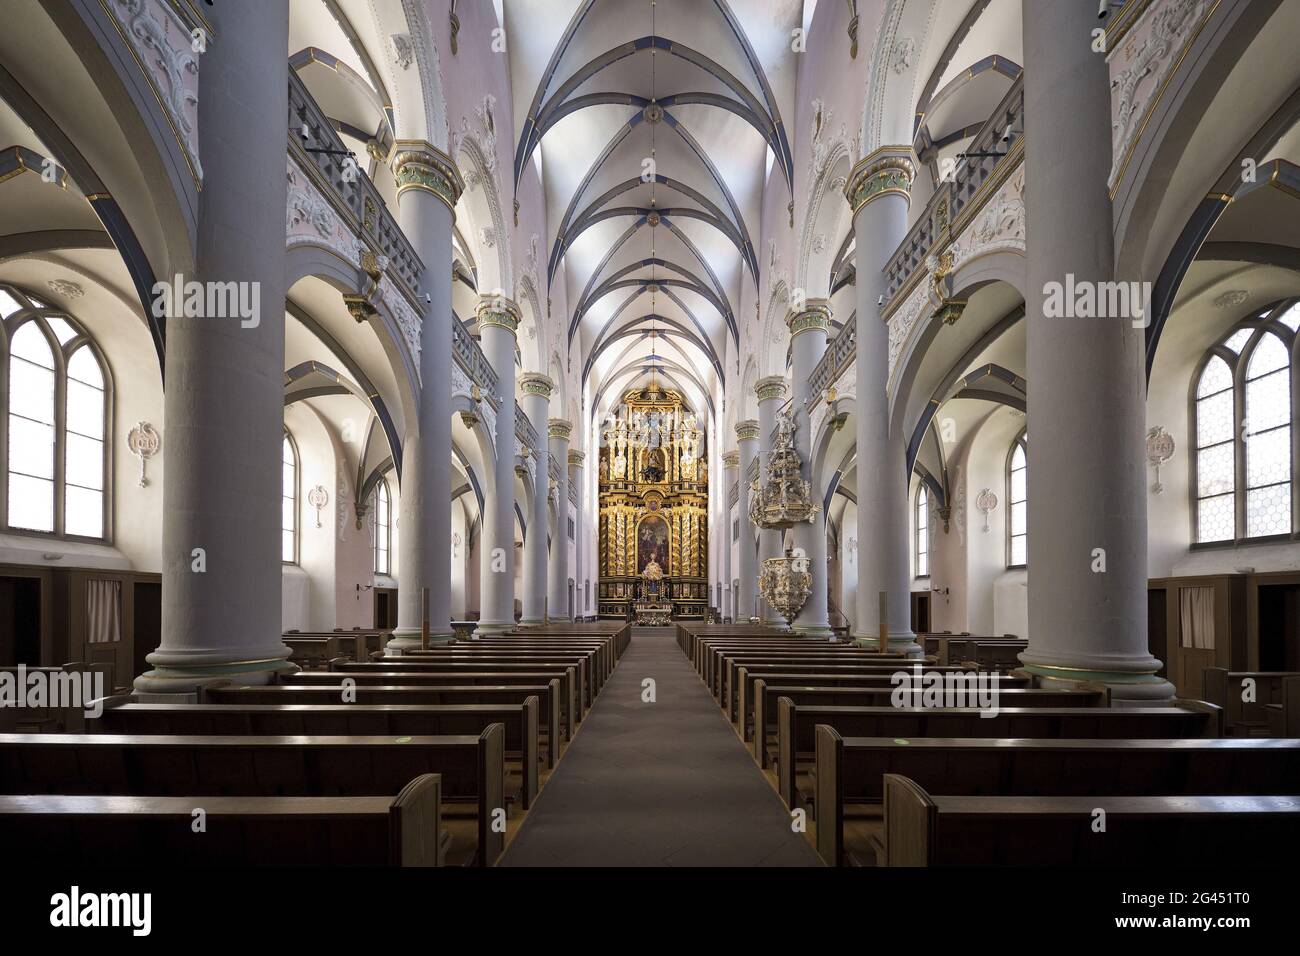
xmin=386 ymin=140 xmax=464 ymax=654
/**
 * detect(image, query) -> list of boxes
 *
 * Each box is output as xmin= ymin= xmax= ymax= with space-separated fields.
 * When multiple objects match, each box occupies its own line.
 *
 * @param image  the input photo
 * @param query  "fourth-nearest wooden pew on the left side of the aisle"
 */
xmin=202 ymin=678 xmax=560 ymax=769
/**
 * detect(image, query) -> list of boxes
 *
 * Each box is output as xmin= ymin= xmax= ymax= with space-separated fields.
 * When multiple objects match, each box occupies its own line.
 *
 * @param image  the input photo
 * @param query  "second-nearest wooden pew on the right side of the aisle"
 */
xmin=813 ymin=724 xmax=1300 ymax=866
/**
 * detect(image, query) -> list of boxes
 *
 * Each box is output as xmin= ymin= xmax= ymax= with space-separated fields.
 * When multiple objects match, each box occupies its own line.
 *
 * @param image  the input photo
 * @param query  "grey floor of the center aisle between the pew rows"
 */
xmin=499 ymin=627 xmax=820 ymax=866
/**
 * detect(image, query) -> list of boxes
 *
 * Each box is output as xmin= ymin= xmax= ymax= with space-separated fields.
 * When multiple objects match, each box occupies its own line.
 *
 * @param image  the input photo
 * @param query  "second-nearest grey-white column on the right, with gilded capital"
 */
xmin=844 ymin=146 xmax=922 ymax=656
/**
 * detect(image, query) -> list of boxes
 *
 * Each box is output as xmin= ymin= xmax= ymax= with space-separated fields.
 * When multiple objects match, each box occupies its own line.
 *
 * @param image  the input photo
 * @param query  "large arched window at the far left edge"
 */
xmin=0 ymin=286 xmax=112 ymax=540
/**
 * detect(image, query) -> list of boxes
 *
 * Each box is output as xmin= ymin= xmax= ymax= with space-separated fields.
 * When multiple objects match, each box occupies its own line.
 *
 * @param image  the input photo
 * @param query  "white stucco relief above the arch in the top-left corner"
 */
xmin=108 ymin=0 xmax=203 ymax=182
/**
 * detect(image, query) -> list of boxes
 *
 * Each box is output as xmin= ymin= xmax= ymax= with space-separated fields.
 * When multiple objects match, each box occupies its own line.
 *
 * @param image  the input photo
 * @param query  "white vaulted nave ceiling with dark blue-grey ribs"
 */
xmin=506 ymin=0 xmax=803 ymax=416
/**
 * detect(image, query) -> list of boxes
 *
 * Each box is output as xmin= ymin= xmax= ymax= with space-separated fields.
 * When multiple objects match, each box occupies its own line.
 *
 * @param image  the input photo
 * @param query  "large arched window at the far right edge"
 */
xmin=1191 ymin=300 xmax=1300 ymax=544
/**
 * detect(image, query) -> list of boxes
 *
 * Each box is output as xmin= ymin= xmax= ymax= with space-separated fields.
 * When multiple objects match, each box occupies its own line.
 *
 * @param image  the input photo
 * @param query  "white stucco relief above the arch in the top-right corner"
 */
xmin=1106 ymin=0 xmax=1212 ymax=189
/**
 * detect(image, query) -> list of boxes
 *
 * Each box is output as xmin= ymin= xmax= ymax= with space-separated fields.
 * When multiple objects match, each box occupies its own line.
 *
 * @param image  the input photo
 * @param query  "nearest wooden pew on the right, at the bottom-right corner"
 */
xmin=884 ymin=774 xmax=1300 ymax=866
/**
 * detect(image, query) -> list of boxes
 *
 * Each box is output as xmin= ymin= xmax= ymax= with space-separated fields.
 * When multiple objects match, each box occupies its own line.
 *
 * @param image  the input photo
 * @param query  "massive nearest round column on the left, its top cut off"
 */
xmin=143 ymin=0 xmax=294 ymax=693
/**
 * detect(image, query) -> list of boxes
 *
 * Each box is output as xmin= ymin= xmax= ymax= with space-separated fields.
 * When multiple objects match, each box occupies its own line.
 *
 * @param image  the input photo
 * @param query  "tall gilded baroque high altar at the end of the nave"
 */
xmin=598 ymin=382 xmax=709 ymax=623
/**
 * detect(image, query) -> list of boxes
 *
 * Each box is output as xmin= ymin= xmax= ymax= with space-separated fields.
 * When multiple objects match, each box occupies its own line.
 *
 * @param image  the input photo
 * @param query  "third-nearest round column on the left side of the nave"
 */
xmin=475 ymin=295 xmax=520 ymax=633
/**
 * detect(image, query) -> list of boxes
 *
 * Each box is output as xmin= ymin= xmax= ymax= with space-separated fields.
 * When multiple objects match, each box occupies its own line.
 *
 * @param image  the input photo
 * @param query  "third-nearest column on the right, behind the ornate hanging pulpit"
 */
xmin=785 ymin=299 xmax=835 ymax=639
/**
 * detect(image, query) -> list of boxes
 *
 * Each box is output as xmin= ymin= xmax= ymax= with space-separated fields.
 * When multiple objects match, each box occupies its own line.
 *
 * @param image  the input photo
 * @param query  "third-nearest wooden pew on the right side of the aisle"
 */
xmin=768 ymin=697 xmax=1223 ymax=808
